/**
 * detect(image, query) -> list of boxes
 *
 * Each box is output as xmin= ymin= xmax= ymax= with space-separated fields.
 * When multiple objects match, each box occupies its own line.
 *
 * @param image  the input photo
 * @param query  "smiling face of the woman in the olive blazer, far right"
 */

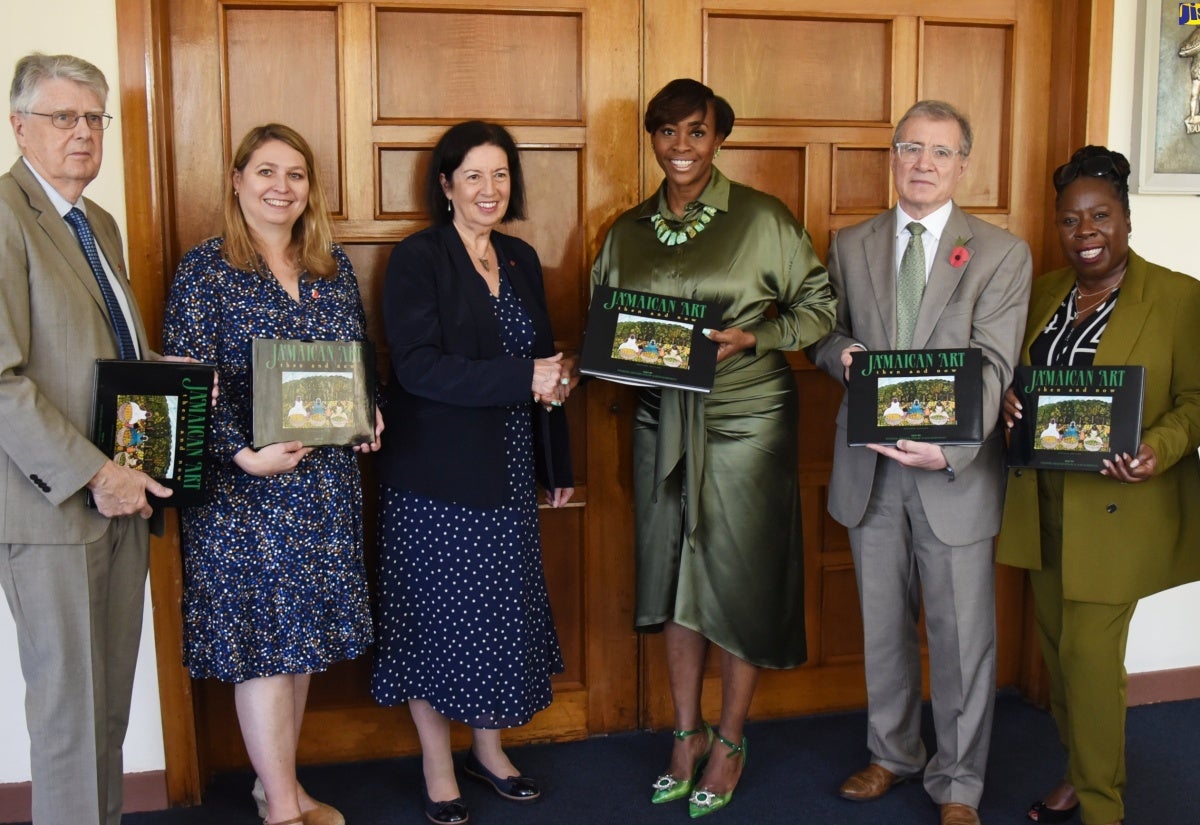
xmin=1055 ymin=176 xmax=1133 ymax=290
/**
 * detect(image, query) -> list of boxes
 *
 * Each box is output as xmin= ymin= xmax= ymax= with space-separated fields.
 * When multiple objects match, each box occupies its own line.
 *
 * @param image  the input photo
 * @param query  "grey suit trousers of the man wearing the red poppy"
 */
xmin=850 ymin=458 xmax=996 ymax=807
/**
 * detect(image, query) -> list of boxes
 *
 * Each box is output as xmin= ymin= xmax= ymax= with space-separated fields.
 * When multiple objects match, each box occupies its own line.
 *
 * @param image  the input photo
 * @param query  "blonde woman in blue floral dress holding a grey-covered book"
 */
xmin=163 ymin=124 xmax=382 ymax=825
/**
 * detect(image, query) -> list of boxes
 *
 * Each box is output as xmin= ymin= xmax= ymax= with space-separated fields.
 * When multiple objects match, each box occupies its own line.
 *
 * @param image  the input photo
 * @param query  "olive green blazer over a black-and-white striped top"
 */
xmin=996 ymin=251 xmax=1200 ymax=604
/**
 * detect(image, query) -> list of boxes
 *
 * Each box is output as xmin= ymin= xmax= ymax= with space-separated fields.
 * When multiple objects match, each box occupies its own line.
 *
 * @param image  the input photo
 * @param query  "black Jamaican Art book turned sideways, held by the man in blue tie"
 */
xmin=88 ymin=359 xmax=216 ymax=507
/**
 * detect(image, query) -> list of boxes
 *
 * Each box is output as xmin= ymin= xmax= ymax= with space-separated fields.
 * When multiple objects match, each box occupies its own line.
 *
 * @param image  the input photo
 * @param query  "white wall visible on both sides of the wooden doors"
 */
xmin=0 ymin=0 xmax=1200 ymax=783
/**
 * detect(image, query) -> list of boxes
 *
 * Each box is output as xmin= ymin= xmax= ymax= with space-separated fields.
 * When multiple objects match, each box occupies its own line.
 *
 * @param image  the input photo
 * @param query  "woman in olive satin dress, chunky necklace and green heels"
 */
xmin=592 ymin=79 xmax=834 ymax=817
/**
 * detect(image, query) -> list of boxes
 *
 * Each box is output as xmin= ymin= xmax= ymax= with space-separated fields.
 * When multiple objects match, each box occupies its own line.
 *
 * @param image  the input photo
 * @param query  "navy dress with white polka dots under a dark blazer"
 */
xmin=371 ymin=267 xmax=563 ymax=728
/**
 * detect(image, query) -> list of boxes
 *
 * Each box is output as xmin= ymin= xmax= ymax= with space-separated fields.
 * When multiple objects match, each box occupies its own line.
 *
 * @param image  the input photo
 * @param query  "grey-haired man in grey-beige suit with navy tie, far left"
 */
xmin=0 ymin=54 xmax=170 ymax=825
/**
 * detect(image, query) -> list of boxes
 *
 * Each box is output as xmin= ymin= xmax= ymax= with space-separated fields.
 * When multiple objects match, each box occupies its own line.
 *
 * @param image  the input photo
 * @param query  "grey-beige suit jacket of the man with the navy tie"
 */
xmin=0 ymin=159 xmax=149 ymax=544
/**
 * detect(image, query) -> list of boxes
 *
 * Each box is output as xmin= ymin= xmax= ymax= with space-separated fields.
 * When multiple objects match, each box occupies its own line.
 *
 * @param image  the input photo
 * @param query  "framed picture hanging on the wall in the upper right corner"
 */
xmin=1130 ymin=0 xmax=1200 ymax=194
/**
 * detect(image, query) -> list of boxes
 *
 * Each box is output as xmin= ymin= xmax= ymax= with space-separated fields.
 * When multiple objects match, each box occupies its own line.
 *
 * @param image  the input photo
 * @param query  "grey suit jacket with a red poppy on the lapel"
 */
xmin=806 ymin=205 xmax=1032 ymax=546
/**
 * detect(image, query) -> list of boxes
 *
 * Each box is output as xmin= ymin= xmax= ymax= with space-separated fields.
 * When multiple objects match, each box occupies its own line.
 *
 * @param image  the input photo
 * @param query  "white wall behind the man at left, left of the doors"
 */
xmin=0 ymin=0 xmax=166 ymax=783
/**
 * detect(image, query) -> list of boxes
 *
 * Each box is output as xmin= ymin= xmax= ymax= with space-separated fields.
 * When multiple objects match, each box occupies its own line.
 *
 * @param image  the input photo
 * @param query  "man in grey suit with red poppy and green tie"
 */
xmin=808 ymin=101 xmax=1031 ymax=825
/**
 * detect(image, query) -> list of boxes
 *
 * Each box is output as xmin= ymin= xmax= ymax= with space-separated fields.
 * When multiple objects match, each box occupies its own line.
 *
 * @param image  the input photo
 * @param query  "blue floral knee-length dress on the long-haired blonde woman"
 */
xmin=163 ymin=239 xmax=372 ymax=682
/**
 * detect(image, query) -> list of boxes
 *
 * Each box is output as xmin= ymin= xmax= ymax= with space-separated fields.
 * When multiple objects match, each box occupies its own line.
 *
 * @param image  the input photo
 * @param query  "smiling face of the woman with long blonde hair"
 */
xmin=233 ymin=140 xmax=308 ymax=236
